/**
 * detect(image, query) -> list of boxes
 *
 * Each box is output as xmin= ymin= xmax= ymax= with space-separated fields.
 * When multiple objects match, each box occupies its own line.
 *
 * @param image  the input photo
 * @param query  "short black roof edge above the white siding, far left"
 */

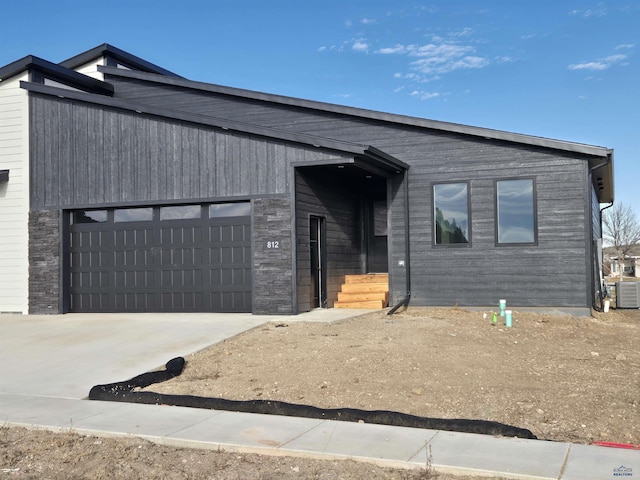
xmin=0 ymin=55 xmax=113 ymax=95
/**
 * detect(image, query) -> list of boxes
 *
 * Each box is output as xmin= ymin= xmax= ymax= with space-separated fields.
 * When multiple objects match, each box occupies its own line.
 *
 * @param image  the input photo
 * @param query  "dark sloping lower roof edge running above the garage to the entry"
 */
xmin=20 ymin=82 xmax=409 ymax=173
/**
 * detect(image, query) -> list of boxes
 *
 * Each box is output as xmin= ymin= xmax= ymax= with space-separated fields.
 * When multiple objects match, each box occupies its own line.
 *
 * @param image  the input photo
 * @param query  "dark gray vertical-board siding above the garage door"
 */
xmin=31 ymin=95 xmax=350 ymax=207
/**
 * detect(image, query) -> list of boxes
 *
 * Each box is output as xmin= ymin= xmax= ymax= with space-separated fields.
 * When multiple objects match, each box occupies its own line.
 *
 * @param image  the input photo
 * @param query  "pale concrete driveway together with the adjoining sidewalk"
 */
xmin=0 ymin=309 xmax=640 ymax=480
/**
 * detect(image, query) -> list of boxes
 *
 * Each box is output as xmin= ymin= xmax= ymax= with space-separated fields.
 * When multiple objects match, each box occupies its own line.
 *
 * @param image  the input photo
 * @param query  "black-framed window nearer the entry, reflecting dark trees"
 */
xmin=433 ymin=182 xmax=471 ymax=245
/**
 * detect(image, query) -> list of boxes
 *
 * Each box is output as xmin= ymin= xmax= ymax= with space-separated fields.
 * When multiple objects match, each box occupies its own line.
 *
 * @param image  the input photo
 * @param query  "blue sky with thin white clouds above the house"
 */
xmin=0 ymin=0 xmax=640 ymax=210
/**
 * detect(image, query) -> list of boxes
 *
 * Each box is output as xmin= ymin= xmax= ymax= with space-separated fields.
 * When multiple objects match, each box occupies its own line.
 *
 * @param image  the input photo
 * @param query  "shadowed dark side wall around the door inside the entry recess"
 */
xmin=296 ymin=168 xmax=364 ymax=312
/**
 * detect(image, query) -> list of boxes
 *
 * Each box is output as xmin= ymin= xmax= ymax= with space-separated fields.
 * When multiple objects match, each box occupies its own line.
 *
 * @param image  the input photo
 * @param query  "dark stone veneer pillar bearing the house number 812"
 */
xmin=253 ymin=198 xmax=297 ymax=315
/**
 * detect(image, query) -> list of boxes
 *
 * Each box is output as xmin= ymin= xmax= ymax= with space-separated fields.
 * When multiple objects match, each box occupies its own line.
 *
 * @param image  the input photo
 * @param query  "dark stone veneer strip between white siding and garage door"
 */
xmin=29 ymin=210 xmax=62 ymax=314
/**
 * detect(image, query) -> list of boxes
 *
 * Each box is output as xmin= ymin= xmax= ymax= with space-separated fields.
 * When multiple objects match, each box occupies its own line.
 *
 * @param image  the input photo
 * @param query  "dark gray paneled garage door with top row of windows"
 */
xmin=69 ymin=202 xmax=251 ymax=312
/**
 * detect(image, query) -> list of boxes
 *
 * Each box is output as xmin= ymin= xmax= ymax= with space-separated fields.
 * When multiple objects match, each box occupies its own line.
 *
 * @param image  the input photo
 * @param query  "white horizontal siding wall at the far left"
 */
xmin=0 ymin=73 xmax=29 ymax=314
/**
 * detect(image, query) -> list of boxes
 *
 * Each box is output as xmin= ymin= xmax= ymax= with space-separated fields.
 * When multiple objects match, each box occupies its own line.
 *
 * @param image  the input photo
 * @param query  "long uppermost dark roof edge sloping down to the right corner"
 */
xmin=99 ymin=67 xmax=609 ymax=157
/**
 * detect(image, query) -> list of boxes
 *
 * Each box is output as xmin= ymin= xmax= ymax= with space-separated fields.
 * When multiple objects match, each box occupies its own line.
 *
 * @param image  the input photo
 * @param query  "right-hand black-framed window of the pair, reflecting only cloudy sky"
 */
xmin=496 ymin=178 xmax=537 ymax=245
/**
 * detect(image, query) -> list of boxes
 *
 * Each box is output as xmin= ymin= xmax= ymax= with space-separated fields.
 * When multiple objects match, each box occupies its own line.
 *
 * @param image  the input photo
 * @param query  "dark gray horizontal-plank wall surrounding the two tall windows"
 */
xmin=109 ymin=77 xmax=593 ymax=307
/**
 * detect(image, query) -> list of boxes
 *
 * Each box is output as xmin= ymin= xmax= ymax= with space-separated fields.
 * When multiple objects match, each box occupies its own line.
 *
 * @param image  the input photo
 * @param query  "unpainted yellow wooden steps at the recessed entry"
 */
xmin=333 ymin=273 xmax=389 ymax=308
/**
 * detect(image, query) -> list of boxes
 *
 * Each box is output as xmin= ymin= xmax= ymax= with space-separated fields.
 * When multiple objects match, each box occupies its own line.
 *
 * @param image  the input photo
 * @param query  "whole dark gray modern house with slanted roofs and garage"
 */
xmin=0 ymin=45 xmax=613 ymax=314
